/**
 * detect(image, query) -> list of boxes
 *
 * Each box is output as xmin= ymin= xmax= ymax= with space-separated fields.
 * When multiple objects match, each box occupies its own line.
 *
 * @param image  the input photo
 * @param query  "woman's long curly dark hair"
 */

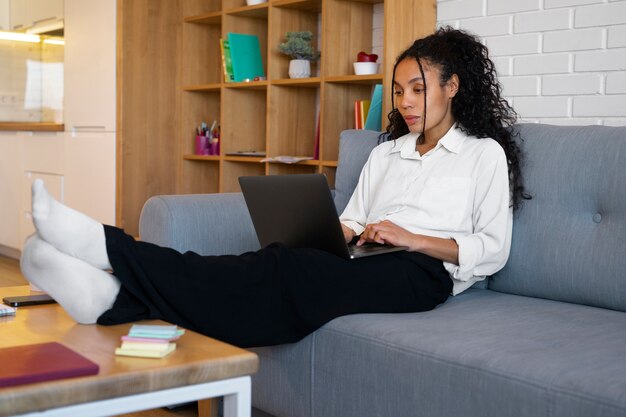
xmin=382 ymin=27 xmax=531 ymax=210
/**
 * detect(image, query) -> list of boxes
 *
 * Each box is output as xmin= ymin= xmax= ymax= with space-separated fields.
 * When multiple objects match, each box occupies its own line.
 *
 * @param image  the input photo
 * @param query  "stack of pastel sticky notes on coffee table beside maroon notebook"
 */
xmin=115 ymin=324 xmax=185 ymax=358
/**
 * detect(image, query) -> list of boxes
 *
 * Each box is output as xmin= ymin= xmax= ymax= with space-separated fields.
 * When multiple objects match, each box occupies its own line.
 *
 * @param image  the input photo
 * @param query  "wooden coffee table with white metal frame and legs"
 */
xmin=0 ymin=286 xmax=258 ymax=417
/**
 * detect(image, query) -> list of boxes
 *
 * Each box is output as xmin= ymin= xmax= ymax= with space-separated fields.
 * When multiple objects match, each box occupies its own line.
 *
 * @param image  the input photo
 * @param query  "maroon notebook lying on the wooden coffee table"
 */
xmin=0 ymin=342 xmax=99 ymax=388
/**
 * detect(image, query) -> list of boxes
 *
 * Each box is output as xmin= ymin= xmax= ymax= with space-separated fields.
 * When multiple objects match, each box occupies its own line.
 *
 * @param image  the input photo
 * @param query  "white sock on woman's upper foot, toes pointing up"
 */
xmin=32 ymin=179 xmax=111 ymax=269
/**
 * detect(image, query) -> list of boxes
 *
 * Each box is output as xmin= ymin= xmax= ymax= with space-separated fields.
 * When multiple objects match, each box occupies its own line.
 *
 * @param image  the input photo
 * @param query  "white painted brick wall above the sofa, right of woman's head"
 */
xmin=437 ymin=0 xmax=626 ymax=126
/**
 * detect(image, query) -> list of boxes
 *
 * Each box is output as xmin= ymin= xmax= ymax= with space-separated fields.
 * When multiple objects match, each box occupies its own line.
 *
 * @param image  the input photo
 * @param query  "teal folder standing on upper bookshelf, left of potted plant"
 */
xmin=228 ymin=33 xmax=265 ymax=82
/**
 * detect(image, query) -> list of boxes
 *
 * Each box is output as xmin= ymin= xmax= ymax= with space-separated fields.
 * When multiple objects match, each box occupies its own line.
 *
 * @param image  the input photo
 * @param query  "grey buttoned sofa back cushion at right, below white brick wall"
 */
xmin=489 ymin=124 xmax=626 ymax=311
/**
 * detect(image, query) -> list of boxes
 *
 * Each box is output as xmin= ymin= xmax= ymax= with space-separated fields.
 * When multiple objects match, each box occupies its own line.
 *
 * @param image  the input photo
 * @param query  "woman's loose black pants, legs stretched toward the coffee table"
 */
xmin=98 ymin=226 xmax=452 ymax=347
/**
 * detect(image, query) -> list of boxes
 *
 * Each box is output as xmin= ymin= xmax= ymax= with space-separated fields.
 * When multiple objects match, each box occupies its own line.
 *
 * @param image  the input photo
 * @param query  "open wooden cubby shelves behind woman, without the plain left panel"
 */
xmin=177 ymin=0 xmax=436 ymax=193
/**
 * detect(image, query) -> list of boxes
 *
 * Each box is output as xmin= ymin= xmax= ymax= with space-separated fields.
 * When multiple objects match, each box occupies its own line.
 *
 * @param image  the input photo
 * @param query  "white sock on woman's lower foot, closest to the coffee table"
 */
xmin=20 ymin=234 xmax=121 ymax=324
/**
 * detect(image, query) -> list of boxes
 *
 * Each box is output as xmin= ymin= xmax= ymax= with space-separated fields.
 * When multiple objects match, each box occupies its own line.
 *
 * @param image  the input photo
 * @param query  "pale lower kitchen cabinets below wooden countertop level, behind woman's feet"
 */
xmin=7 ymin=132 xmax=115 ymax=250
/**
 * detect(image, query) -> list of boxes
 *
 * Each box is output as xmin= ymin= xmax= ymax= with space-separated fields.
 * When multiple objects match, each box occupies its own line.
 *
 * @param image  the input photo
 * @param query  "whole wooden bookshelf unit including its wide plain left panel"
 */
xmin=117 ymin=0 xmax=436 ymax=235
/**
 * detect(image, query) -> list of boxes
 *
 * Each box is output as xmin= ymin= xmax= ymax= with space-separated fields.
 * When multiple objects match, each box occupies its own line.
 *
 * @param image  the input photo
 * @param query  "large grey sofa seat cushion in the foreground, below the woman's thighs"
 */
xmin=310 ymin=290 xmax=626 ymax=417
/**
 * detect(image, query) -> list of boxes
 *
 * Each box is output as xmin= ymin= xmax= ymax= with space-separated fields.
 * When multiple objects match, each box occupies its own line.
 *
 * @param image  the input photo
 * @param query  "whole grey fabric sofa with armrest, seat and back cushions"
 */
xmin=140 ymin=124 xmax=626 ymax=417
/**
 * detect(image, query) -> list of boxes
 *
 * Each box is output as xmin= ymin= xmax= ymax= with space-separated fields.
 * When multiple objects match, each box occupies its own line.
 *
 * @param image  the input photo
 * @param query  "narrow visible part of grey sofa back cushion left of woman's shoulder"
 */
xmin=335 ymin=129 xmax=380 ymax=214
